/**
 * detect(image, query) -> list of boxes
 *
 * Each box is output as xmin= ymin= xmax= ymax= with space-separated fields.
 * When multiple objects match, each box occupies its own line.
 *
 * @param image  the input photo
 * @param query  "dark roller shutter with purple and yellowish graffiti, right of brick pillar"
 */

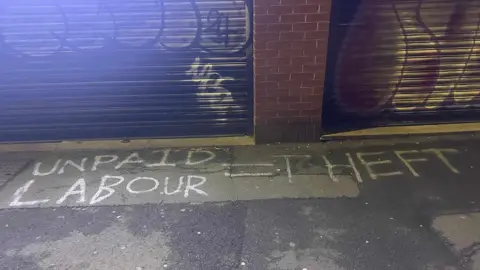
xmin=324 ymin=0 xmax=480 ymax=130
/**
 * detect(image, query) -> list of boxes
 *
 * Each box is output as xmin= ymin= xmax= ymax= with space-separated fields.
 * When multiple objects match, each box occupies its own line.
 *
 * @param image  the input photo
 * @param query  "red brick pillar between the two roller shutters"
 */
xmin=253 ymin=0 xmax=330 ymax=143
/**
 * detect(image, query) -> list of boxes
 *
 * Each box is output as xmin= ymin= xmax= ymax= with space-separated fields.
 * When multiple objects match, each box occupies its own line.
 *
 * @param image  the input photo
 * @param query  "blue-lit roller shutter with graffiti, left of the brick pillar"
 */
xmin=0 ymin=0 xmax=253 ymax=141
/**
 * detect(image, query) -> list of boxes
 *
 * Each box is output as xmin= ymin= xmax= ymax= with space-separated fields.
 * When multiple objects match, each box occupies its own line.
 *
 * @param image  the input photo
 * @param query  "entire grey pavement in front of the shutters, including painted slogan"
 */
xmin=0 ymin=135 xmax=480 ymax=269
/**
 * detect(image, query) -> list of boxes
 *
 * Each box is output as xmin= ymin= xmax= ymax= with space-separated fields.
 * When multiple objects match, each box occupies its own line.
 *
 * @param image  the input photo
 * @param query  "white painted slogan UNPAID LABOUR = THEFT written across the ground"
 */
xmin=9 ymin=148 xmax=460 ymax=207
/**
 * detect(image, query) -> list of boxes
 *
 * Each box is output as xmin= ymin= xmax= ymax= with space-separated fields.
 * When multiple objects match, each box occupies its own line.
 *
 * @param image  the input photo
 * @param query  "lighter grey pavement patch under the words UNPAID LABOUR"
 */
xmin=0 ymin=147 xmax=358 ymax=208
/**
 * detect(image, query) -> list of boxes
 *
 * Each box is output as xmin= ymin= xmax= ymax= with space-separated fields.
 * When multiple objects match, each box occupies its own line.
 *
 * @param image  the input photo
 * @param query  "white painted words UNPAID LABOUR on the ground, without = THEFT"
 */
xmin=10 ymin=149 xmax=216 ymax=207
